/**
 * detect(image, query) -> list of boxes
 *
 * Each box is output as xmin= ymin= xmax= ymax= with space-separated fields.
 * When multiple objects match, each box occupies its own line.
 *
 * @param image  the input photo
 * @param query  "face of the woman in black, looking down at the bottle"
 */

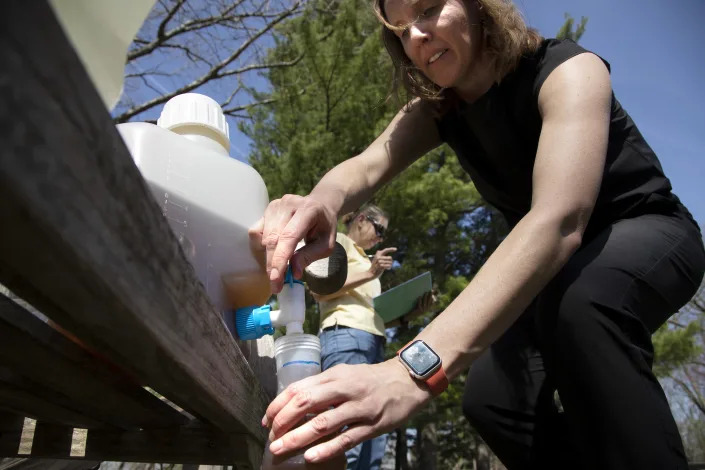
xmin=382 ymin=0 xmax=482 ymax=88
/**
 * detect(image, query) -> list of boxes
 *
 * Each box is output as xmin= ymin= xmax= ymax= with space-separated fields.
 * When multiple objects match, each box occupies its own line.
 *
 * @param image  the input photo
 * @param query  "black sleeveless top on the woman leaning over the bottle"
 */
xmin=437 ymin=39 xmax=695 ymax=237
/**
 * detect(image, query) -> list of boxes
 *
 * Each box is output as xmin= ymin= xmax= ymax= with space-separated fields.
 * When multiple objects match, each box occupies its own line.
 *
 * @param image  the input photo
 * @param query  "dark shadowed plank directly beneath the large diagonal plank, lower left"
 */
xmin=0 ymin=295 xmax=188 ymax=429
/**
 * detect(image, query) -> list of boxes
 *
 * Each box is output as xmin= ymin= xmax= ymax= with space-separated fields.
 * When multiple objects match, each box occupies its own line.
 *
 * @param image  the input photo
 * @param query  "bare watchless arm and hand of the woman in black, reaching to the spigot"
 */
xmin=262 ymin=100 xmax=441 ymax=292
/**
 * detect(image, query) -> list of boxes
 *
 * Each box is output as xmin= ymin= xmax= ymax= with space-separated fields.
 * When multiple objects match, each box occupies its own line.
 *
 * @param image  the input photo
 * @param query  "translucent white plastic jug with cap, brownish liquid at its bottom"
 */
xmin=117 ymin=93 xmax=271 ymax=312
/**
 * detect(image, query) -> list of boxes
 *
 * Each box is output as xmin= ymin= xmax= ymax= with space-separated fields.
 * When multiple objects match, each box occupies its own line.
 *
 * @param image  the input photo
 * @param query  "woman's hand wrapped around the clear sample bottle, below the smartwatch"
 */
xmin=262 ymin=358 xmax=432 ymax=462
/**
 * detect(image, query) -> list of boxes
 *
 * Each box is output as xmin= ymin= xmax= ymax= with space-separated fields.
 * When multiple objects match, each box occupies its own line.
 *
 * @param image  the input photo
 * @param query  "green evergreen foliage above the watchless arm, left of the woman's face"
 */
xmin=241 ymin=0 xmax=392 ymax=199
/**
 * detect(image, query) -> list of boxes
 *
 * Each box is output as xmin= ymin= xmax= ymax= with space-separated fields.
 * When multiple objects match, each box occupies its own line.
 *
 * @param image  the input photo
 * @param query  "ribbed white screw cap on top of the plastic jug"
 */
xmin=157 ymin=93 xmax=230 ymax=148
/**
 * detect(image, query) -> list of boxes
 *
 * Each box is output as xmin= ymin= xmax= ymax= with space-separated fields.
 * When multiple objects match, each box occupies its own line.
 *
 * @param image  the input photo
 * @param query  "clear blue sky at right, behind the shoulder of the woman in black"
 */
xmin=515 ymin=0 xmax=705 ymax=227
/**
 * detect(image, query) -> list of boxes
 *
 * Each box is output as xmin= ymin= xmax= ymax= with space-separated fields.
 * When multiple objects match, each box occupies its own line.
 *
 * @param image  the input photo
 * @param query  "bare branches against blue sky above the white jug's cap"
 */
xmin=113 ymin=0 xmax=305 ymax=123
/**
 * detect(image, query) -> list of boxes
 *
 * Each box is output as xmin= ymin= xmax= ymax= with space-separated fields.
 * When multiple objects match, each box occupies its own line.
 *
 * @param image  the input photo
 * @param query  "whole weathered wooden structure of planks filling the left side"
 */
xmin=0 ymin=1 xmax=275 ymax=469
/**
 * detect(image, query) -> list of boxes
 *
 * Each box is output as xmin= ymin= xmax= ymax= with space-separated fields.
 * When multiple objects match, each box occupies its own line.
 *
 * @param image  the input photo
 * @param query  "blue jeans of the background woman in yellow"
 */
xmin=320 ymin=328 xmax=387 ymax=470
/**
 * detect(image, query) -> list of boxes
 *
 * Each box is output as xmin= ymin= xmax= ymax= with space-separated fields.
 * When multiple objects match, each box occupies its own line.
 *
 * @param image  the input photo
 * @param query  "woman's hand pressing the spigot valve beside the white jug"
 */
xmin=249 ymin=194 xmax=337 ymax=294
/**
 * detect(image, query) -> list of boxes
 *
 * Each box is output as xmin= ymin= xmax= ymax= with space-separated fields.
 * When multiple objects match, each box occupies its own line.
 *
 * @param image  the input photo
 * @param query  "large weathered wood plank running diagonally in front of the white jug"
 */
xmin=0 ymin=2 xmax=268 ymax=445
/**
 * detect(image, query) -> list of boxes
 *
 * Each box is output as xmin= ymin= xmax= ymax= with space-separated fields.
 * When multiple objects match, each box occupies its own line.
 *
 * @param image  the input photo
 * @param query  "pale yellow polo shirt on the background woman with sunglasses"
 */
xmin=318 ymin=233 xmax=384 ymax=336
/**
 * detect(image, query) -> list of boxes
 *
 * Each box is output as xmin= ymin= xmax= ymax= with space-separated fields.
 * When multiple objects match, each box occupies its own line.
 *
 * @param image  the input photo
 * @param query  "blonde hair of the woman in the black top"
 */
xmin=373 ymin=0 xmax=542 ymax=102
